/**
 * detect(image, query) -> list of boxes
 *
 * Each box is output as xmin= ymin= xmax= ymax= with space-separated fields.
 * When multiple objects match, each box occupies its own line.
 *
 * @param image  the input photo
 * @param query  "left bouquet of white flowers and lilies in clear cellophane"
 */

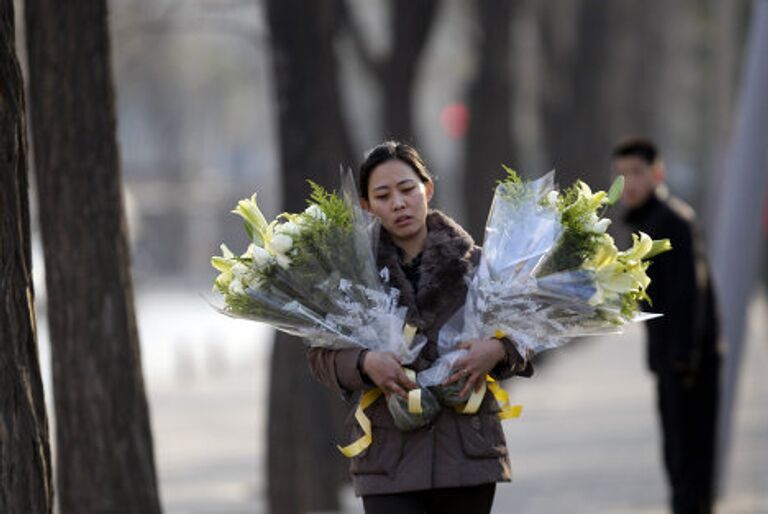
xmin=211 ymin=173 xmax=426 ymax=363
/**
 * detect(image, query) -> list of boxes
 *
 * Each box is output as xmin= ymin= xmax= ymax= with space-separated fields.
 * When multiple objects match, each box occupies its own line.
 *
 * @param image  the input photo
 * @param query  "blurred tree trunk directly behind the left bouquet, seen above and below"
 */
xmin=266 ymin=0 xmax=352 ymax=514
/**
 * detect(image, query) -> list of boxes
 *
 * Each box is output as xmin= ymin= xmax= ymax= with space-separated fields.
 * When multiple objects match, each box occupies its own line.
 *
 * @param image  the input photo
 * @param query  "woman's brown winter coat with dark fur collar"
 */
xmin=308 ymin=211 xmax=531 ymax=496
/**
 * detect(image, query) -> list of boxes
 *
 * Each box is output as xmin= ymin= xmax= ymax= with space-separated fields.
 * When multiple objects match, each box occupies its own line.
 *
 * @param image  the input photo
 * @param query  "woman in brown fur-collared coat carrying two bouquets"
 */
xmin=309 ymin=142 xmax=532 ymax=514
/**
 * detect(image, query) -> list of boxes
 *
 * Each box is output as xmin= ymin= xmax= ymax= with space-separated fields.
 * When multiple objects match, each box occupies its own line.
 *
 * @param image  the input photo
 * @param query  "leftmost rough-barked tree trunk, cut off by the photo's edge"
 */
xmin=0 ymin=0 xmax=53 ymax=514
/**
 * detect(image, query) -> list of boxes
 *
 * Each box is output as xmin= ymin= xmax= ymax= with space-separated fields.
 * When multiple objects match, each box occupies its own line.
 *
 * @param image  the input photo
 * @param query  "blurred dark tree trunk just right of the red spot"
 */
xmin=463 ymin=0 xmax=515 ymax=244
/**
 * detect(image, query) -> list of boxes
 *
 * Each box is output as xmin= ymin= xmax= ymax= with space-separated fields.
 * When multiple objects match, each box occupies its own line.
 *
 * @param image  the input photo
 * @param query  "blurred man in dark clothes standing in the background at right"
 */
xmin=612 ymin=138 xmax=720 ymax=514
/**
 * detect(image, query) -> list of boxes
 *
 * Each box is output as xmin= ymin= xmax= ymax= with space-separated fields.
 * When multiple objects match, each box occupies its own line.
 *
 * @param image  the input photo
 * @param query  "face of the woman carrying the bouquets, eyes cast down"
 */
xmin=362 ymin=159 xmax=434 ymax=240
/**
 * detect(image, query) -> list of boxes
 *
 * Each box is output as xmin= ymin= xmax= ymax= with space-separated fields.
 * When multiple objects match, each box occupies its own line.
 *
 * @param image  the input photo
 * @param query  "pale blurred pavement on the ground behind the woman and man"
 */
xmin=150 ymin=294 xmax=768 ymax=514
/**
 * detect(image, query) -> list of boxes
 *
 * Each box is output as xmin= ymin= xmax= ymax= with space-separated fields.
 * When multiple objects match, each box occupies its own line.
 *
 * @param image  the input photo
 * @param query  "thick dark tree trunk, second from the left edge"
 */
xmin=26 ymin=0 xmax=160 ymax=514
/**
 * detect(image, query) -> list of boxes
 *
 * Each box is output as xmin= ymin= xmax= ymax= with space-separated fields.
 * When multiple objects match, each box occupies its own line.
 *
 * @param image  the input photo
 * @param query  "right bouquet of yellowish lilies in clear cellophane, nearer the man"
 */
xmin=419 ymin=167 xmax=671 ymax=386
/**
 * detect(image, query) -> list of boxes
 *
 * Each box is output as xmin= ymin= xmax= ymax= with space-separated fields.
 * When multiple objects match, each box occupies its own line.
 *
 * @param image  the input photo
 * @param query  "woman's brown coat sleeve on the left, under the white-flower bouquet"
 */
xmin=307 ymin=348 xmax=370 ymax=397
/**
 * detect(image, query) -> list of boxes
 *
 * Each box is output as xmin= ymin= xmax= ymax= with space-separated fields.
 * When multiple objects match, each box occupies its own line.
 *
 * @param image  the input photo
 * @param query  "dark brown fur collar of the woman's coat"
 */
xmin=378 ymin=210 xmax=478 ymax=330
